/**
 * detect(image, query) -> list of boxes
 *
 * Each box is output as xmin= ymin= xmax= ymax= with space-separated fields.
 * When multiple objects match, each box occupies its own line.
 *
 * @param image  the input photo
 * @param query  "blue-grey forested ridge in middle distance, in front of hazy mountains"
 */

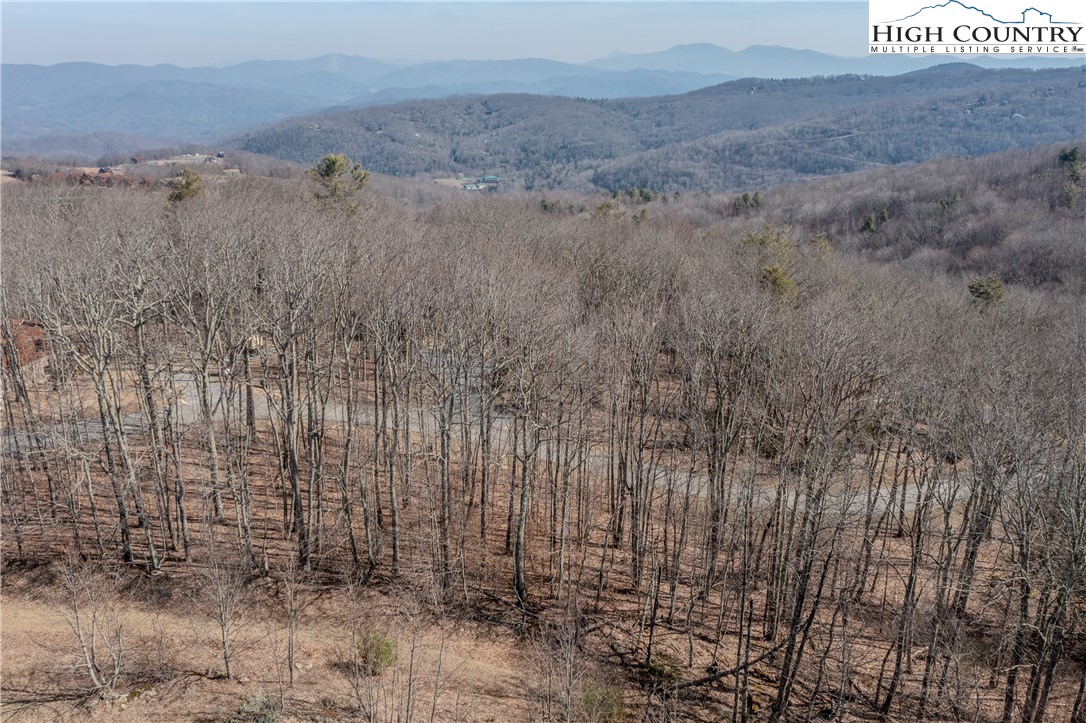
xmin=233 ymin=64 xmax=1086 ymax=192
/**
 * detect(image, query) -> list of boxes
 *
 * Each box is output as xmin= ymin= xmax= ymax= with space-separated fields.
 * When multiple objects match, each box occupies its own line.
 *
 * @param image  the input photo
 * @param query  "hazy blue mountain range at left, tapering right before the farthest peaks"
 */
xmin=2 ymin=55 xmax=735 ymax=157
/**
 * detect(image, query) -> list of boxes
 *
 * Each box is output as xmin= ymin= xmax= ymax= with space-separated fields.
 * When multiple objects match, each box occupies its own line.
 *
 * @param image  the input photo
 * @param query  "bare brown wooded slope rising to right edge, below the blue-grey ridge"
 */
xmin=664 ymin=137 xmax=1086 ymax=293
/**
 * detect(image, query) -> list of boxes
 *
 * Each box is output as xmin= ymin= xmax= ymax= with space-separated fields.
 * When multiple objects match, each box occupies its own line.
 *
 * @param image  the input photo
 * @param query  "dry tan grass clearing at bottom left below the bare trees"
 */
xmin=0 ymin=567 xmax=533 ymax=722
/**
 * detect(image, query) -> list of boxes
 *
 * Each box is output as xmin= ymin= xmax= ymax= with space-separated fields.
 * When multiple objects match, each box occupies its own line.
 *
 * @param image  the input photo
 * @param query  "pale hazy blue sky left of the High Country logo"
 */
xmin=0 ymin=0 xmax=868 ymax=66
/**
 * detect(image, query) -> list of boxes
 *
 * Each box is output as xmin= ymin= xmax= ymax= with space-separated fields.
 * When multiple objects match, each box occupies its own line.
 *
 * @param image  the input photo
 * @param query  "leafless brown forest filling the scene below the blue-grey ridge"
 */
xmin=0 ymin=142 xmax=1086 ymax=723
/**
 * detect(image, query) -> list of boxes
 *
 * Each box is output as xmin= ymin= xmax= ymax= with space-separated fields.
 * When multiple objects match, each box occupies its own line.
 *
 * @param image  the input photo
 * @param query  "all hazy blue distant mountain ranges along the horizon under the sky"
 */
xmin=2 ymin=45 xmax=1082 ymax=157
